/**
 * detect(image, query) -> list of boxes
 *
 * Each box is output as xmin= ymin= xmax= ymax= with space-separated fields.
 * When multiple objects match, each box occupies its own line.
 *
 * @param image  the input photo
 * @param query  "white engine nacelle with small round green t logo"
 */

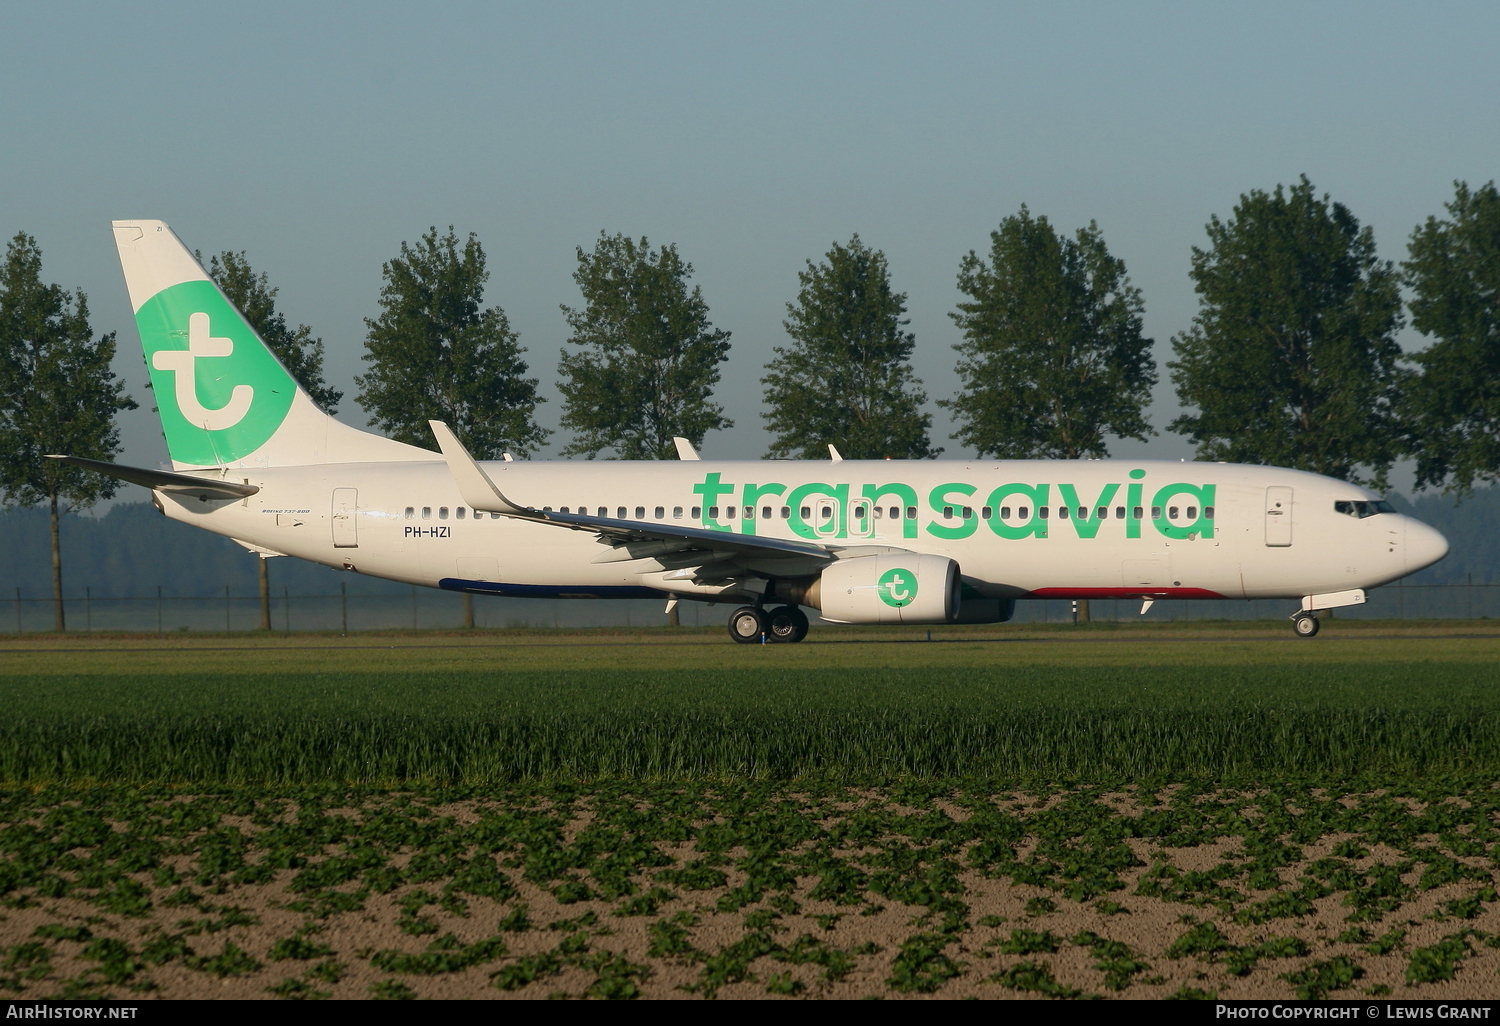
xmin=819 ymin=552 xmax=959 ymax=624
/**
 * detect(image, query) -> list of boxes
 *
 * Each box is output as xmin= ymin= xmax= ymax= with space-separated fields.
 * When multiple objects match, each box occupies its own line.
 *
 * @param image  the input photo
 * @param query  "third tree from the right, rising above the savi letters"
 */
xmin=939 ymin=206 xmax=1157 ymax=459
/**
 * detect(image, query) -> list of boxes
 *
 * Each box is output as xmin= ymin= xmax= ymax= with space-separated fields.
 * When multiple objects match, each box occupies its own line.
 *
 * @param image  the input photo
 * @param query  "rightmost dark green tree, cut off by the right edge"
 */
xmin=1403 ymin=182 xmax=1500 ymax=494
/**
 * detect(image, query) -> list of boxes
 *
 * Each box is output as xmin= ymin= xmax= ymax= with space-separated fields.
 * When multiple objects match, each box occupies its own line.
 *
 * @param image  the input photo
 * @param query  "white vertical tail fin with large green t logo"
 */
xmin=114 ymin=221 xmax=438 ymax=470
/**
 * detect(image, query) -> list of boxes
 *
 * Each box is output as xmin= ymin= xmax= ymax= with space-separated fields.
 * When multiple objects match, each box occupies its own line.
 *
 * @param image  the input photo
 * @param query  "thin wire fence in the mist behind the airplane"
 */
xmin=0 ymin=582 xmax=1500 ymax=635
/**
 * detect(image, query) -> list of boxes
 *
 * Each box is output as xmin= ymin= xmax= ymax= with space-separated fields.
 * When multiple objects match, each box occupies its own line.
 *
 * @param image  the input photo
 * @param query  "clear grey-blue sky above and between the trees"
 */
xmin=0 ymin=3 xmax=1500 ymax=465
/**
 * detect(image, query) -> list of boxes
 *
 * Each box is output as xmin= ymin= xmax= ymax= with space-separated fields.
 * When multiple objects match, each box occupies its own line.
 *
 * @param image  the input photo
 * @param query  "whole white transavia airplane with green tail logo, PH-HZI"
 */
xmin=57 ymin=221 xmax=1448 ymax=644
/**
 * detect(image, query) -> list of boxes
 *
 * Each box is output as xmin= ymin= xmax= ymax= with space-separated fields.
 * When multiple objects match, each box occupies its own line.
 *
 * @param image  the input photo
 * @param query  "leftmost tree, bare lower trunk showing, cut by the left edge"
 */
xmin=0 ymin=233 xmax=135 ymax=632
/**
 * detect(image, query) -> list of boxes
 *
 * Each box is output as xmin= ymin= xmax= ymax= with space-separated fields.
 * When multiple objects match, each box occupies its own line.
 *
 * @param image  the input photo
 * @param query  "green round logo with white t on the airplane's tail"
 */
xmin=135 ymin=281 xmax=297 ymax=467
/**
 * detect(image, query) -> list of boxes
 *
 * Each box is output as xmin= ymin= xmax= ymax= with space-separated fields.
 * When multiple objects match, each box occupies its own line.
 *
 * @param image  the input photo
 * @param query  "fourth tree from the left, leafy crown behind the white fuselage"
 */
xmin=558 ymin=233 xmax=734 ymax=459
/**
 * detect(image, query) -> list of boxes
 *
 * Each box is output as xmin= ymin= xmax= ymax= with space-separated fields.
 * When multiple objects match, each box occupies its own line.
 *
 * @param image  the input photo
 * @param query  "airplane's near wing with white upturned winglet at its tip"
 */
xmin=428 ymin=420 xmax=887 ymax=563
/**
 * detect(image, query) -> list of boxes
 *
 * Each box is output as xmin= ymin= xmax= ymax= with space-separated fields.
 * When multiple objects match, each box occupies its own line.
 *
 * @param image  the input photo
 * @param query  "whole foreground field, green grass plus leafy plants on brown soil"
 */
xmin=0 ymin=621 xmax=1500 ymax=998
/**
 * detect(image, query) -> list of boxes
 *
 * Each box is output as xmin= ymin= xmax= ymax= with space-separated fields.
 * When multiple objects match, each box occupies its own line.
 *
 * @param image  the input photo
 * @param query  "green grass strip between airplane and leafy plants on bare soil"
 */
xmin=0 ymin=621 xmax=1500 ymax=786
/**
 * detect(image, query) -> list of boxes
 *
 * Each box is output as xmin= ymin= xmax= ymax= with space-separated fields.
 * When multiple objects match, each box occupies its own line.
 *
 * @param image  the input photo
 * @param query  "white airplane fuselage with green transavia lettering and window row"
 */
xmin=158 ymin=455 xmax=1448 ymax=599
